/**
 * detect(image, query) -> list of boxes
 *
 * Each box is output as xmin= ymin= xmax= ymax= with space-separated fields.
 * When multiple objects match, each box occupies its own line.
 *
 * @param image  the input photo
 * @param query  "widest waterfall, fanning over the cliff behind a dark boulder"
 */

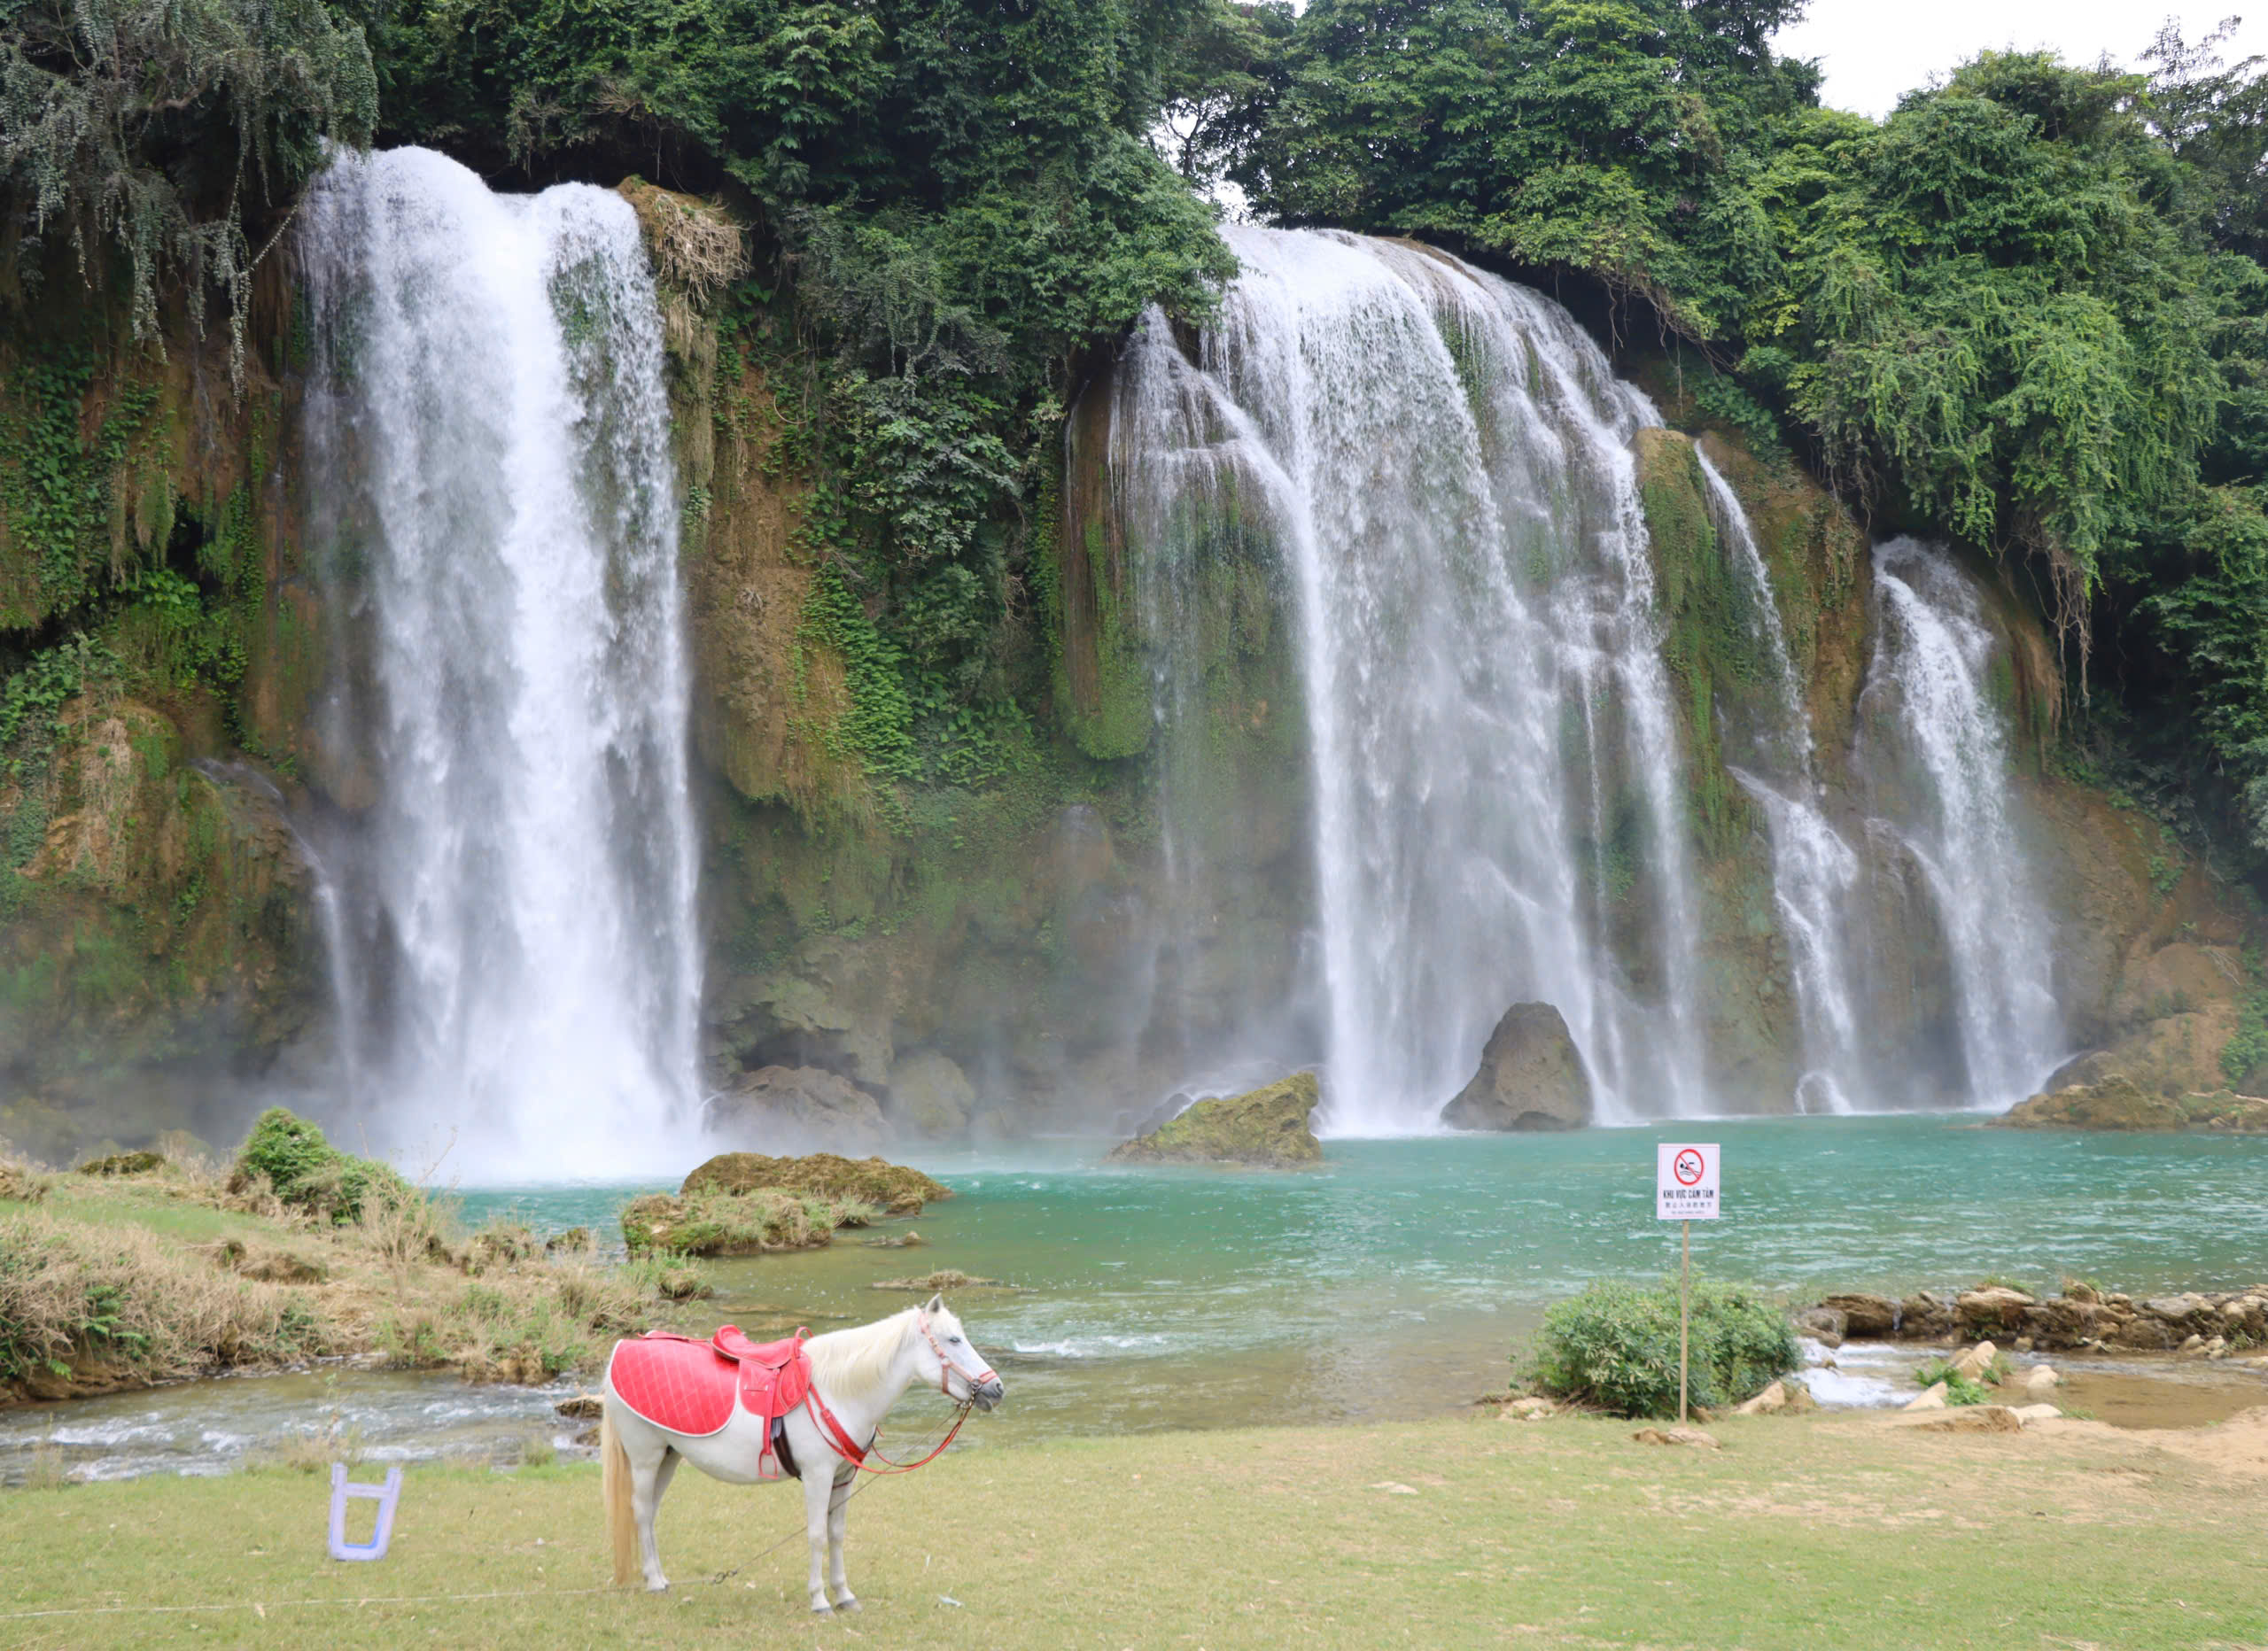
xmin=1114 ymin=229 xmax=1705 ymax=1134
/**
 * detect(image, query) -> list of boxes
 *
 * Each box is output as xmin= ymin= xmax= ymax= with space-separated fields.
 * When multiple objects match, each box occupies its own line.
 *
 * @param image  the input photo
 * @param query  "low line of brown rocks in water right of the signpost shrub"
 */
xmin=1794 ymin=1279 xmax=2268 ymax=1359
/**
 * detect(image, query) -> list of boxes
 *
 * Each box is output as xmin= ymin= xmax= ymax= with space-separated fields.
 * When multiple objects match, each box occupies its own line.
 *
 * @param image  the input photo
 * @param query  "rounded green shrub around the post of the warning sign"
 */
xmin=1526 ymin=1279 xmax=1801 ymax=1415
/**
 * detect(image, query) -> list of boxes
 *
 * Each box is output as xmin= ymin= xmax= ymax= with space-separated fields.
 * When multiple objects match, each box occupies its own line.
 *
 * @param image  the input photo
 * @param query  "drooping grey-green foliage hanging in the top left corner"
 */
xmin=0 ymin=0 xmax=377 ymax=369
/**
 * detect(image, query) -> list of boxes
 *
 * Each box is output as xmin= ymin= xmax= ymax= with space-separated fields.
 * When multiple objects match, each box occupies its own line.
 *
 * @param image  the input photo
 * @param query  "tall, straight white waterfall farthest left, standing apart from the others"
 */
xmin=299 ymin=150 xmax=701 ymax=1179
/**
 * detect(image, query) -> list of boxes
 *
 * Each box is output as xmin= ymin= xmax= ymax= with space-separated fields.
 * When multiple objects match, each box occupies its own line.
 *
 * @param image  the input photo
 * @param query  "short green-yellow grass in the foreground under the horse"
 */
xmin=0 ymin=1413 xmax=2268 ymax=1651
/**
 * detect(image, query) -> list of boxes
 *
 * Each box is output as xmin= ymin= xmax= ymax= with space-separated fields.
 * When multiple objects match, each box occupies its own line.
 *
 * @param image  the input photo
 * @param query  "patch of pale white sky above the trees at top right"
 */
xmin=1771 ymin=0 xmax=2268 ymax=118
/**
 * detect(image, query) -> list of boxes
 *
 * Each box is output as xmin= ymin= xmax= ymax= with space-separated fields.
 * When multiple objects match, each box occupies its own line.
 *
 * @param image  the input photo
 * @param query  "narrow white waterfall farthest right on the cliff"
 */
xmin=1860 ymin=538 xmax=2062 ymax=1106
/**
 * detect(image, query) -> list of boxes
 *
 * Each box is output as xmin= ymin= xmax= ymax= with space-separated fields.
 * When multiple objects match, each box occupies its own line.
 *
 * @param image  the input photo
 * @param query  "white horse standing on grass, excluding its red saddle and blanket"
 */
xmin=599 ymin=1295 xmax=1003 ymax=1617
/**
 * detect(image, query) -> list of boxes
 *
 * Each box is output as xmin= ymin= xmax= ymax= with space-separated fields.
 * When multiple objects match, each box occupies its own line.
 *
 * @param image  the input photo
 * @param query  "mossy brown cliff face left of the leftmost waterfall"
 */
xmin=0 ymin=260 xmax=327 ymax=1154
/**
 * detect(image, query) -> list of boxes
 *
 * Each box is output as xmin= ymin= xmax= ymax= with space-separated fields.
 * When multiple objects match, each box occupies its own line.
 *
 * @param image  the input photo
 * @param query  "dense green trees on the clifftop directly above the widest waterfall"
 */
xmin=1200 ymin=0 xmax=1817 ymax=338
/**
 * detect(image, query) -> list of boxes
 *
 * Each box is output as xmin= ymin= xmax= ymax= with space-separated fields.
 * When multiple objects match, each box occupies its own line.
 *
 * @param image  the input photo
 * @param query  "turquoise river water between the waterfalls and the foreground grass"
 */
xmin=0 ymin=1116 xmax=2268 ymax=1478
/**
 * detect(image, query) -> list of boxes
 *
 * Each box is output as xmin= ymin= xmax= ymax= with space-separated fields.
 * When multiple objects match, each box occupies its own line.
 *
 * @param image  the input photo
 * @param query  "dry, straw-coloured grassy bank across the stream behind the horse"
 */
xmin=0 ymin=1143 xmax=675 ymax=1404
